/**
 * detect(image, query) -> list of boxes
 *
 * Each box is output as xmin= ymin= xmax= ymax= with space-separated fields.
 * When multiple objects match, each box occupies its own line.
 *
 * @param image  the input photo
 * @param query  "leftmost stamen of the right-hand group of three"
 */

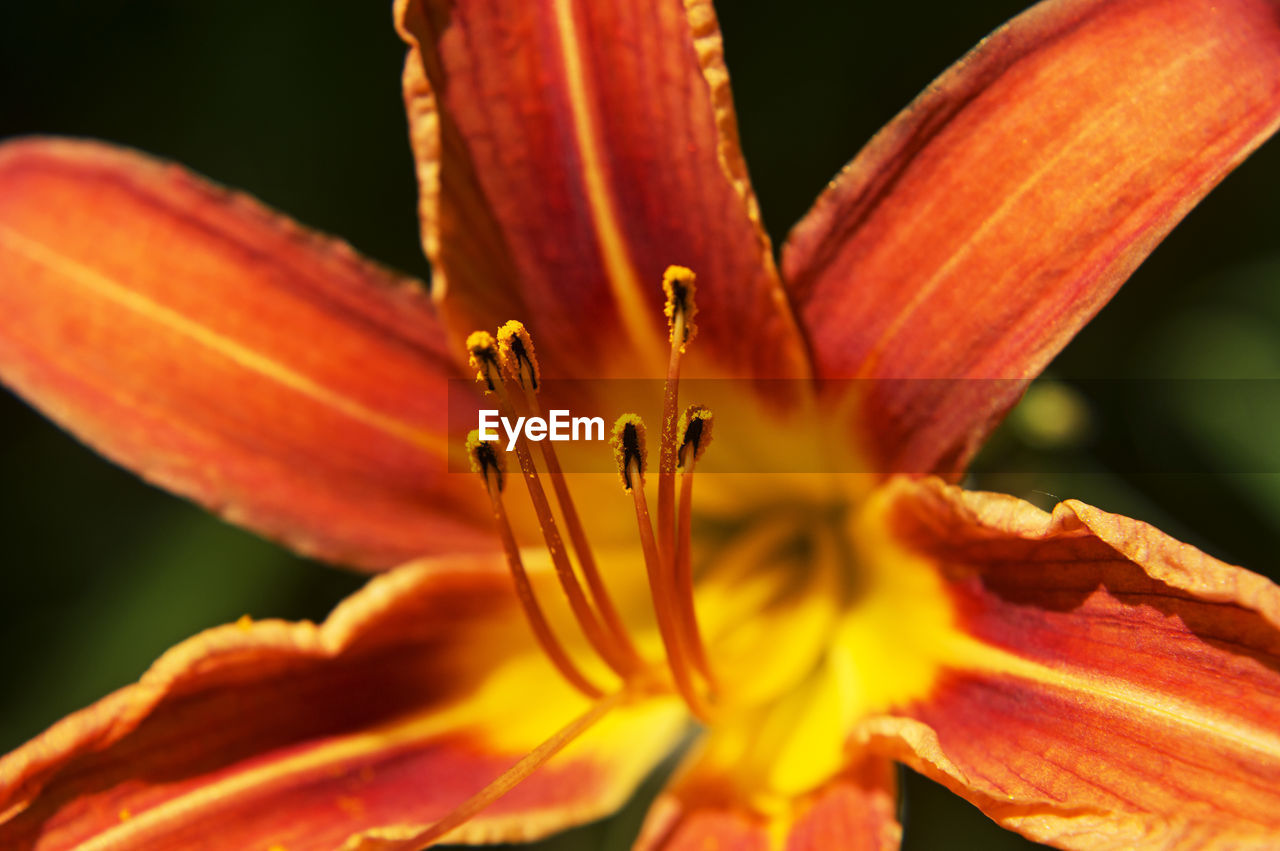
xmin=611 ymin=413 xmax=710 ymax=722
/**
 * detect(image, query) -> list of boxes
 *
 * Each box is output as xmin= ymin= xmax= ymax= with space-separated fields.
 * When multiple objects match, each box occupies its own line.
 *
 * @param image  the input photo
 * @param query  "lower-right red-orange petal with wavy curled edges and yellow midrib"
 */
xmin=861 ymin=481 xmax=1280 ymax=850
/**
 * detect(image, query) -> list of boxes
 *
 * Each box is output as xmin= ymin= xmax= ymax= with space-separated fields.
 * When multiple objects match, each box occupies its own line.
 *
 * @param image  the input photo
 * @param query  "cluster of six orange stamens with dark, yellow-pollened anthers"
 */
xmin=466 ymin=266 xmax=716 ymax=722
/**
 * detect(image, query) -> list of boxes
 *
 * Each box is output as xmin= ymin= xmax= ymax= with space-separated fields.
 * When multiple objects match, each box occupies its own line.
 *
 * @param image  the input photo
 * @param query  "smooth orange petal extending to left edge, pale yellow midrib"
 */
xmin=0 ymin=139 xmax=492 ymax=568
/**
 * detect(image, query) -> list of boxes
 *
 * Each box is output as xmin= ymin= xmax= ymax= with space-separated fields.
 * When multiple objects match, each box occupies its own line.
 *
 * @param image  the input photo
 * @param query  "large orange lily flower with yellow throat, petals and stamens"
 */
xmin=0 ymin=0 xmax=1280 ymax=851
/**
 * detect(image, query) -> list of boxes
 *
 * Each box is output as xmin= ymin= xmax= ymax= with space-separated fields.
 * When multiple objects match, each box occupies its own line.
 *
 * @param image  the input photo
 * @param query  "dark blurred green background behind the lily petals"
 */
xmin=0 ymin=0 xmax=1280 ymax=851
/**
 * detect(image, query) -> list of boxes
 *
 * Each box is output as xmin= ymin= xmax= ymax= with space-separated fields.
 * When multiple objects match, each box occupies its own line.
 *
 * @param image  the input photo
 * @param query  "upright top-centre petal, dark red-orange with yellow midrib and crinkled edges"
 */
xmin=396 ymin=0 xmax=808 ymax=378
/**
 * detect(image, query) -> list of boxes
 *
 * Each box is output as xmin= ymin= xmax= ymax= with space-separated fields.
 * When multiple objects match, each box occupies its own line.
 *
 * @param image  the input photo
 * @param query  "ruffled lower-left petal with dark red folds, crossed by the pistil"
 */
xmin=0 ymin=557 xmax=685 ymax=851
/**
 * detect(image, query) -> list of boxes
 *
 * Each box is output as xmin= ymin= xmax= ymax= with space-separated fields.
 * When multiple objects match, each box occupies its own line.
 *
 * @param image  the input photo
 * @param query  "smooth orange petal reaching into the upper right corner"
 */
xmin=782 ymin=0 xmax=1280 ymax=472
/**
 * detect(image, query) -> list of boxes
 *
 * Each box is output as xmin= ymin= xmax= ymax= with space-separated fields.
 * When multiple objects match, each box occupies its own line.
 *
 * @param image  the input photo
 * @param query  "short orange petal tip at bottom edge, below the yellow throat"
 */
xmin=636 ymin=754 xmax=902 ymax=851
